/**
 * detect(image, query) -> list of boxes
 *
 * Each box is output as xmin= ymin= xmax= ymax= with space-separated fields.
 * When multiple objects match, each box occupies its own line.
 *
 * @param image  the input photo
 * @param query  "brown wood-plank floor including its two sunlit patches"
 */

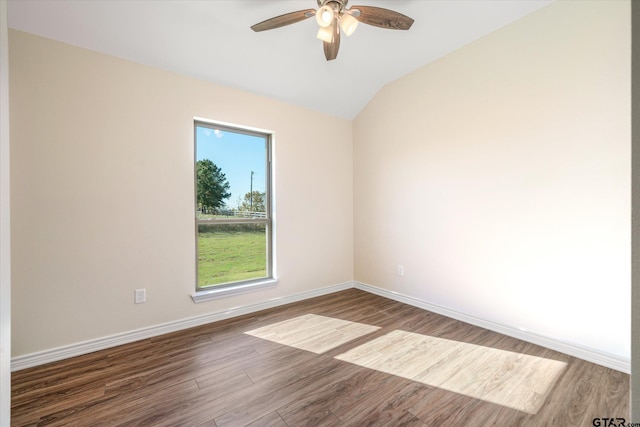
xmin=11 ymin=289 xmax=631 ymax=426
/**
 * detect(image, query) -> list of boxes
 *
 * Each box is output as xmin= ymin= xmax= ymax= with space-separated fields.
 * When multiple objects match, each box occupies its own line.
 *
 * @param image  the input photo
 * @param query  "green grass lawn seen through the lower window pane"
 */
xmin=198 ymin=224 xmax=267 ymax=287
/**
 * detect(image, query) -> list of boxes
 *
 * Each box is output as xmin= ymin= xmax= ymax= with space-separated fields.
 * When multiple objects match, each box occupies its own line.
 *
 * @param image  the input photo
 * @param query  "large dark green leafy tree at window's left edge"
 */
xmin=196 ymin=159 xmax=231 ymax=213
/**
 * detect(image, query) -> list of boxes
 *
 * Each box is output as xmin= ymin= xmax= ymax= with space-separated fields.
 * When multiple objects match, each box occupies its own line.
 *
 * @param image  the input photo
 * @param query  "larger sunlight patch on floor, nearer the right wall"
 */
xmin=336 ymin=330 xmax=567 ymax=414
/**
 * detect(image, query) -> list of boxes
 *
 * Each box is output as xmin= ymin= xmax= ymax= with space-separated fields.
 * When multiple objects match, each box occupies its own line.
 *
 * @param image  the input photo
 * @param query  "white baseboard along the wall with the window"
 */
xmin=11 ymin=282 xmax=353 ymax=371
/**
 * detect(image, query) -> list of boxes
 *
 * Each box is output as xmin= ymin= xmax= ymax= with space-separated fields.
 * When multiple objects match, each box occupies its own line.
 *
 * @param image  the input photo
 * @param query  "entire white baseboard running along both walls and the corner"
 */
xmin=11 ymin=282 xmax=631 ymax=374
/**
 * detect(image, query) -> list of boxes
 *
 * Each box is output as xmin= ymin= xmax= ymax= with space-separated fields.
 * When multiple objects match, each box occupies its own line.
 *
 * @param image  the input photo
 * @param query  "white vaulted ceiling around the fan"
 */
xmin=8 ymin=0 xmax=551 ymax=119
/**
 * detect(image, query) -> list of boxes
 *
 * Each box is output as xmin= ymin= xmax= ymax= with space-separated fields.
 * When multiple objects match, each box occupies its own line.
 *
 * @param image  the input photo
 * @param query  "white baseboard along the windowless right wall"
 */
xmin=354 ymin=282 xmax=631 ymax=374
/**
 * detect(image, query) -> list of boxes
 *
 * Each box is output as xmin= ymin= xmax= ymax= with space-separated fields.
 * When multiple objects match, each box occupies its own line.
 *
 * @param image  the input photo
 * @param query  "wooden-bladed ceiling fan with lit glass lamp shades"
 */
xmin=251 ymin=0 xmax=413 ymax=61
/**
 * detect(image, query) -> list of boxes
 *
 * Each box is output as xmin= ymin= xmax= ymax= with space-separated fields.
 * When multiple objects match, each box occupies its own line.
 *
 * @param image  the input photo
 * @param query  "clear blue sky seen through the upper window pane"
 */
xmin=196 ymin=126 xmax=266 ymax=208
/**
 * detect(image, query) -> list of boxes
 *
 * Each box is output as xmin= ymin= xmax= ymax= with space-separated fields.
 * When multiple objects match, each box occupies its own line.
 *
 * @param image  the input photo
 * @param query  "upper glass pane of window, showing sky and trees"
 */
xmin=196 ymin=126 xmax=267 ymax=219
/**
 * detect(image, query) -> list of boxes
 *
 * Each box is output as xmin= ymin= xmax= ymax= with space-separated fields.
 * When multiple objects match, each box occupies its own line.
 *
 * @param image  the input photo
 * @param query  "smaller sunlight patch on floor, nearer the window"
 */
xmin=245 ymin=314 xmax=380 ymax=354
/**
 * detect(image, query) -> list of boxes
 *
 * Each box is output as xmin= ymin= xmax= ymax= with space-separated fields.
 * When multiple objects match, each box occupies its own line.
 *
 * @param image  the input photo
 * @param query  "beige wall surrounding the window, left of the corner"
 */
xmin=9 ymin=31 xmax=353 ymax=356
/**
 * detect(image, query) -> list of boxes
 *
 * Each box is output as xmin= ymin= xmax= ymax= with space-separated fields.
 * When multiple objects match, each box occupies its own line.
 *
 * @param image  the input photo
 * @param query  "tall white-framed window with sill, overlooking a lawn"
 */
xmin=194 ymin=120 xmax=273 ymax=301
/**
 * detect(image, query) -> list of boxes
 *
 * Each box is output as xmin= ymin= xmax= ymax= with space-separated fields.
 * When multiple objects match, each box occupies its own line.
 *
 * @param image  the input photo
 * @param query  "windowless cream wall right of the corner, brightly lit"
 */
xmin=354 ymin=1 xmax=631 ymax=358
